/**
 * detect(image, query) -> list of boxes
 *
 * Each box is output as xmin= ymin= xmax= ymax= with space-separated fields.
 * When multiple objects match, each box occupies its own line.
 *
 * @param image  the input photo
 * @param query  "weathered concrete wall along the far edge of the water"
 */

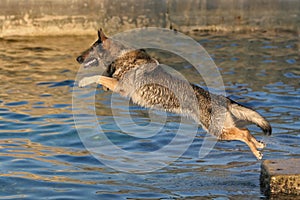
xmin=0 ymin=0 xmax=300 ymax=37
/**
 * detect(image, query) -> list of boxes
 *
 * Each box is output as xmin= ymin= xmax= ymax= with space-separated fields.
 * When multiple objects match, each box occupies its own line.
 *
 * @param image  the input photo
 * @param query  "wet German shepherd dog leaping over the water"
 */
xmin=77 ymin=29 xmax=272 ymax=160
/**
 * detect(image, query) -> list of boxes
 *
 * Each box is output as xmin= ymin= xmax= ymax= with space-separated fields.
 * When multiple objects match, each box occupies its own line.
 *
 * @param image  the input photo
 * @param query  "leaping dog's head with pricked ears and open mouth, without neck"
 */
xmin=76 ymin=29 xmax=125 ymax=70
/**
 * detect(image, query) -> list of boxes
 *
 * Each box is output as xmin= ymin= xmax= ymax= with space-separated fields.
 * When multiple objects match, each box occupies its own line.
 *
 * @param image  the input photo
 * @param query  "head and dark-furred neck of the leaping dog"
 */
xmin=76 ymin=29 xmax=158 ymax=79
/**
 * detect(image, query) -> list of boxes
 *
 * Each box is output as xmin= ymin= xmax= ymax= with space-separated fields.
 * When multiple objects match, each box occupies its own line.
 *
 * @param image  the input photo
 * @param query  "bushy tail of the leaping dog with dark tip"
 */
xmin=229 ymin=101 xmax=272 ymax=135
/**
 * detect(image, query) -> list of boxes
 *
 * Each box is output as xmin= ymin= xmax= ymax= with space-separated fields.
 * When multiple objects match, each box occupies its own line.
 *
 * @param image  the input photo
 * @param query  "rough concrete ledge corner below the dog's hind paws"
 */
xmin=260 ymin=158 xmax=300 ymax=196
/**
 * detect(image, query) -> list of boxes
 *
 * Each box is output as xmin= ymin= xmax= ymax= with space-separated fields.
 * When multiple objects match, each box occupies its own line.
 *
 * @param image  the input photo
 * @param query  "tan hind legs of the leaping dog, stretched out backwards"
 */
xmin=219 ymin=127 xmax=263 ymax=160
